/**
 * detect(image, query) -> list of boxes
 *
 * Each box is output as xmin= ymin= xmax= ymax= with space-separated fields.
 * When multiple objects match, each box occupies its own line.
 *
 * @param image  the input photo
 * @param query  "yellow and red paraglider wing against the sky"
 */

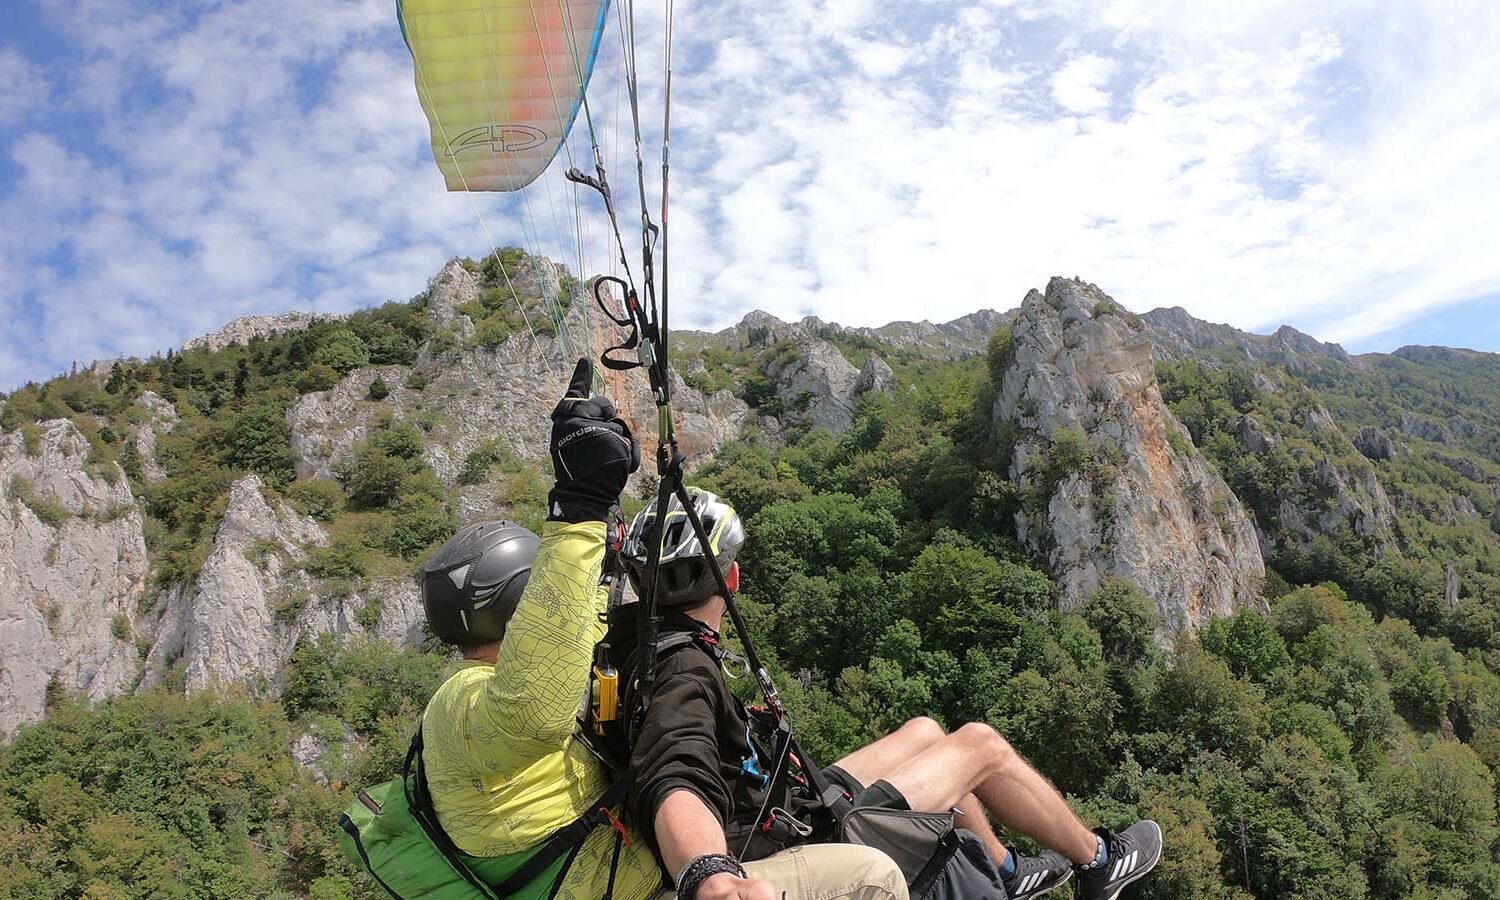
xmin=396 ymin=0 xmax=609 ymax=191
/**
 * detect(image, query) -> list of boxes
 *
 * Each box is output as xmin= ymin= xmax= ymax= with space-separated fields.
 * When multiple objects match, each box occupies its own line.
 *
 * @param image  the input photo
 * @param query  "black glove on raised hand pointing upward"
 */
xmin=548 ymin=359 xmax=641 ymax=522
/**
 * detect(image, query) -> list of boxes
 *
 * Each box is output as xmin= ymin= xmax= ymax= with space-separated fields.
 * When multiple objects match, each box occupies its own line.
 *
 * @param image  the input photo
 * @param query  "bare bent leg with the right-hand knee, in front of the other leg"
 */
xmin=876 ymin=723 xmax=1098 ymax=863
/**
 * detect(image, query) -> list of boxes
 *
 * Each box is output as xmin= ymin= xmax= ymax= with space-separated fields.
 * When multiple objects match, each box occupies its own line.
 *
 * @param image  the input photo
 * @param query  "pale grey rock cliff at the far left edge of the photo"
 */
xmin=0 ymin=420 xmax=147 ymax=737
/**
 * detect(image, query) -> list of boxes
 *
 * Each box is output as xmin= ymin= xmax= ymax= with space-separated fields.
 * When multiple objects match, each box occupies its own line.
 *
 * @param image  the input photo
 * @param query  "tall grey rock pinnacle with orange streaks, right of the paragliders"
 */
xmin=995 ymin=279 xmax=1265 ymax=635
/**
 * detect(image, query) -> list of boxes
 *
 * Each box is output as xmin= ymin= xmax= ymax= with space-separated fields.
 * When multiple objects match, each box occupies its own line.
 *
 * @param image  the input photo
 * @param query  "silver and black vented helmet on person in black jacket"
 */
xmin=621 ymin=488 xmax=746 ymax=606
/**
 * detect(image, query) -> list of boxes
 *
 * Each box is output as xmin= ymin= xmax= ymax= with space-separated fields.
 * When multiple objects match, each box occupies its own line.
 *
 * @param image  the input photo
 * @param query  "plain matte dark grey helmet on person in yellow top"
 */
xmin=422 ymin=522 xmax=542 ymax=647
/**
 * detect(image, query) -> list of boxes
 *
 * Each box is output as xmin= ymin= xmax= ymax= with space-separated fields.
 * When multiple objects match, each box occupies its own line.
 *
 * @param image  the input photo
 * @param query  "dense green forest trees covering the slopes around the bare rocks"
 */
xmin=0 ymin=256 xmax=1500 ymax=900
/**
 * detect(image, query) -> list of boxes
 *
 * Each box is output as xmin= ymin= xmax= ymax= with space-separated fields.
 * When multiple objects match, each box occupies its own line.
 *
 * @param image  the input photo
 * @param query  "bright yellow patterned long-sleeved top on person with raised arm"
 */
xmin=422 ymin=522 xmax=662 ymax=900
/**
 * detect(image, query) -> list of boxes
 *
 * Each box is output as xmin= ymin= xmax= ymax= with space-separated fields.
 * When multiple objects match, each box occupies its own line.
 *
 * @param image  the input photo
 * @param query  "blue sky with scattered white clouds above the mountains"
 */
xmin=0 ymin=0 xmax=1500 ymax=390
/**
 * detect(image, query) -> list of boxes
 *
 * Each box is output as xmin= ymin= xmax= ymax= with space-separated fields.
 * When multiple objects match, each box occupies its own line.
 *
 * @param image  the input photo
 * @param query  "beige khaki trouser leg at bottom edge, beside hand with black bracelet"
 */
xmin=651 ymin=845 xmax=908 ymax=900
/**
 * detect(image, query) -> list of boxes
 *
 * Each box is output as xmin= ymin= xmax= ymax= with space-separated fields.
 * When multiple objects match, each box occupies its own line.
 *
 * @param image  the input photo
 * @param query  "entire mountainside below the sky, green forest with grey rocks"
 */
xmin=0 ymin=256 xmax=1500 ymax=900
